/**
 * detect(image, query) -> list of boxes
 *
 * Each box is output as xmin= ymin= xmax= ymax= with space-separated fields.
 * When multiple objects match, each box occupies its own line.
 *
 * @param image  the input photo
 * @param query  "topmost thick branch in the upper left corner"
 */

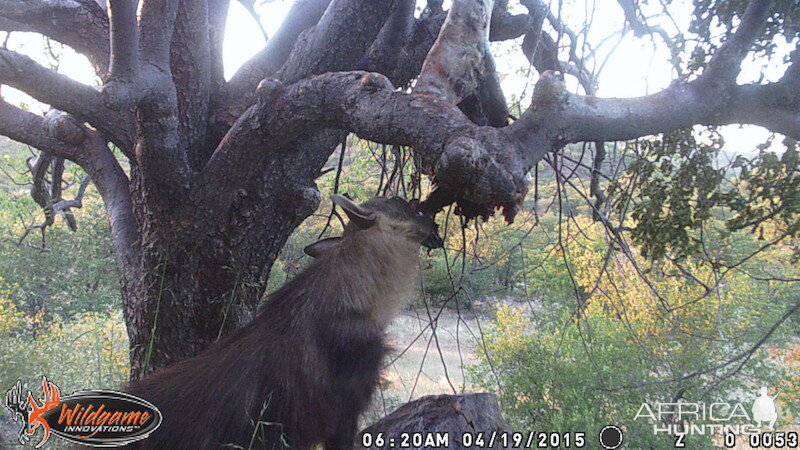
xmin=0 ymin=0 xmax=109 ymax=77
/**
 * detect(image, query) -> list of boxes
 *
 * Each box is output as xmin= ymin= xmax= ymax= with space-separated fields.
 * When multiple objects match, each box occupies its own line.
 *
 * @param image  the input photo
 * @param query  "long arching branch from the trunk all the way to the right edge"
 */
xmin=209 ymin=62 xmax=800 ymax=223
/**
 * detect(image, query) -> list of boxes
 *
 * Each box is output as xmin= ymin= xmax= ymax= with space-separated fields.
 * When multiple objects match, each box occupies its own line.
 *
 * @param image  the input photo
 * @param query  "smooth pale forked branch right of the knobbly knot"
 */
xmin=512 ymin=1 xmax=800 ymax=145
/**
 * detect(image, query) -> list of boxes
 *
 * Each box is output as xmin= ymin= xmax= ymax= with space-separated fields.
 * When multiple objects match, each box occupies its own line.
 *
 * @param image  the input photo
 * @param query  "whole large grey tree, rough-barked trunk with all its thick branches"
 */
xmin=0 ymin=0 xmax=800 ymax=378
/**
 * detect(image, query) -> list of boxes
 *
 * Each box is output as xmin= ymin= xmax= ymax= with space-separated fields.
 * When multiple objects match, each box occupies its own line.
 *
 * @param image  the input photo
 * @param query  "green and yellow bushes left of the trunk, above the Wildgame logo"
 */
xmin=0 ymin=141 xmax=129 ymax=393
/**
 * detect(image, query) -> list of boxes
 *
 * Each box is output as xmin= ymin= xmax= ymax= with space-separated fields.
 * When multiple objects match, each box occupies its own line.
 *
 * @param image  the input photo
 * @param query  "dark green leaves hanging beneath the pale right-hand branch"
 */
xmin=609 ymin=130 xmax=800 ymax=260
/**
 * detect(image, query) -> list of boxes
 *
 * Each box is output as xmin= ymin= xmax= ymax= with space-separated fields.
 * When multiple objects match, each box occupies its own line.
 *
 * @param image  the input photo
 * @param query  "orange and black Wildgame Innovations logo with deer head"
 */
xmin=5 ymin=377 xmax=161 ymax=448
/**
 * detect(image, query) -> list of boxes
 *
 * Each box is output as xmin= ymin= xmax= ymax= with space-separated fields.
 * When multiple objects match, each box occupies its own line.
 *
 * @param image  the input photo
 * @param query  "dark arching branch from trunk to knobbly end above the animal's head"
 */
xmin=198 ymin=72 xmax=527 ymax=222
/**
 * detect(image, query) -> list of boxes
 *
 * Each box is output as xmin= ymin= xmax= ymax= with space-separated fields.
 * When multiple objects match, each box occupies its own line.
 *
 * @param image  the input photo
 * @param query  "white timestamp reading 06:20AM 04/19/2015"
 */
xmin=361 ymin=431 xmax=586 ymax=449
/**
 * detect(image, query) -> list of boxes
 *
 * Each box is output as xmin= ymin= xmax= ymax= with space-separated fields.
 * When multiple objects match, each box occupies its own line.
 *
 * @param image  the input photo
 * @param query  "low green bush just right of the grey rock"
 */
xmin=471 ymin=308 xmax=684 ymax=448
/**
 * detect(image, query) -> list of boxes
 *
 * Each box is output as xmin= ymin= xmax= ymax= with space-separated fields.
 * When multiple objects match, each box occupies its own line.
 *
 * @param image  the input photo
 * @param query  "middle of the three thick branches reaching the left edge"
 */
xmin=0 ymin=49 xmax=135 ymax=155
